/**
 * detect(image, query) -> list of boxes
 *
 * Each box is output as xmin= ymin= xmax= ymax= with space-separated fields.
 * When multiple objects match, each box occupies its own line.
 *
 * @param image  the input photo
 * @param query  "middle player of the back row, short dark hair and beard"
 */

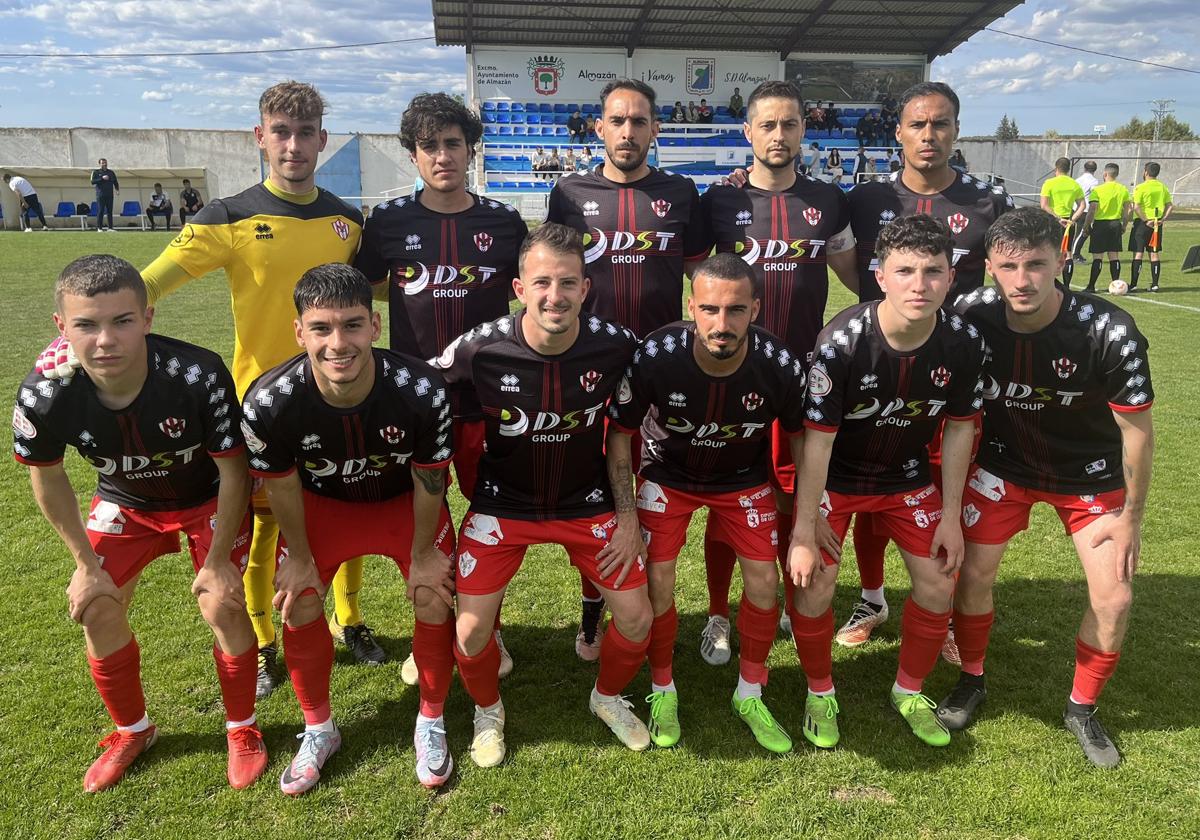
xmin=546 ymin=79 xmax=709 ymax=661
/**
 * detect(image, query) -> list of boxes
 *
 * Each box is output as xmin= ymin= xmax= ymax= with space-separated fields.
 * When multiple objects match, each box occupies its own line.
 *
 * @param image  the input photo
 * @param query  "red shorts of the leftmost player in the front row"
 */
xmin=88 ymin=496 xmax=251 ymax=587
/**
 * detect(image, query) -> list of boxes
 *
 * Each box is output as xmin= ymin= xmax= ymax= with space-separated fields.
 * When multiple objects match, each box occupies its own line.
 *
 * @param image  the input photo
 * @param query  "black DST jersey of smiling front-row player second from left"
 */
xmin=242 ymin=348 xmax=454 ymax=502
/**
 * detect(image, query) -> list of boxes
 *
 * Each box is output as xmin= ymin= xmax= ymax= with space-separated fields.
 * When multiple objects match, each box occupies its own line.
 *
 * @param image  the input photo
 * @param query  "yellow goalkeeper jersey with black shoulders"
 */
xmin=142 ymin=181 xmax=362 ymax=395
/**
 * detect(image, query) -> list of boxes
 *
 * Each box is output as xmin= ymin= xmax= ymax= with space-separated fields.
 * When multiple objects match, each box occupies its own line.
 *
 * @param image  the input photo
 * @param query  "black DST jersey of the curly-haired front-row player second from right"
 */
xmin=805 ymin=301 xmax=984 ymax=496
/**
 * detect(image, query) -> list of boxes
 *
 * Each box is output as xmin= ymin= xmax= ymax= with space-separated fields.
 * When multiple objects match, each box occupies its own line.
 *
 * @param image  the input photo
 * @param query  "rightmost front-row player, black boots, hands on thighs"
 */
xmin=937 ymin=208 xmax=1154 ymax=767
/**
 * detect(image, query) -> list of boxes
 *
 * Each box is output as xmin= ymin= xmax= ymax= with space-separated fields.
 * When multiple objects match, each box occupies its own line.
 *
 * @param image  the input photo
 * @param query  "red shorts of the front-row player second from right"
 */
xmin=821 ymin=484 xmax=942 ymax=565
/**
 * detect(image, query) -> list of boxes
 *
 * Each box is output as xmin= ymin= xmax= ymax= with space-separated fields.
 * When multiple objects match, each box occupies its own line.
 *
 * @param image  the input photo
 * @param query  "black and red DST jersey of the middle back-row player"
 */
xmin=546 ymin=164 xmax=709 ymax=337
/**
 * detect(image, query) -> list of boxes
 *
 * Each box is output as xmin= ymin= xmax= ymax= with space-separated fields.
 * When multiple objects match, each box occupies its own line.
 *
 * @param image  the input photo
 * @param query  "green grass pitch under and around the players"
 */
xmin=0 ymin=222 xmax=1200 ymax=840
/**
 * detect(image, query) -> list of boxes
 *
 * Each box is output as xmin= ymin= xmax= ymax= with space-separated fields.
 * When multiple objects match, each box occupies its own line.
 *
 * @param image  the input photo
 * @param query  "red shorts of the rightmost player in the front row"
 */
xmin=962 ymin=466 xmax=1124 ymax=545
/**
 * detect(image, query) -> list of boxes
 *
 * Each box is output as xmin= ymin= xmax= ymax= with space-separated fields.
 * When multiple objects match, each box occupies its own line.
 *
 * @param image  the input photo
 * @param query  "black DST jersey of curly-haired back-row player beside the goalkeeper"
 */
xmin=354 ymin=193 xmax=529 ymax=419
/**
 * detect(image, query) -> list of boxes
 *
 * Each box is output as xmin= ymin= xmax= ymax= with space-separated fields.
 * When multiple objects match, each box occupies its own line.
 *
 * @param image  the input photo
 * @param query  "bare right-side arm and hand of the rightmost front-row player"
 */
xmin=1091 ymin=409 xmax=1154 ymax=582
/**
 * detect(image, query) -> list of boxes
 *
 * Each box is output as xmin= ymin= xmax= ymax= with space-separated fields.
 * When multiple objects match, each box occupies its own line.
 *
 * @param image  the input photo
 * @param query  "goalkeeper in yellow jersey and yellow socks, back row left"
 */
xmin=142 ymin=82 xmax=385 ymax=697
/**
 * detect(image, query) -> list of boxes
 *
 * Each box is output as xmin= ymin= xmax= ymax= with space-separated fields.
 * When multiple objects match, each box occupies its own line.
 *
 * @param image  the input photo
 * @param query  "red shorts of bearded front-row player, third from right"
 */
xmin=637 ymin=479 xmax=779 ymax=563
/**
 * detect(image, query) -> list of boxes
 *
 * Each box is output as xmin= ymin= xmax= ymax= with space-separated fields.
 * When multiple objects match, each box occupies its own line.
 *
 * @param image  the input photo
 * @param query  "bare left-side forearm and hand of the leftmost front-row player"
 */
xmin=29 ymin=462 xmax=124 ymax=622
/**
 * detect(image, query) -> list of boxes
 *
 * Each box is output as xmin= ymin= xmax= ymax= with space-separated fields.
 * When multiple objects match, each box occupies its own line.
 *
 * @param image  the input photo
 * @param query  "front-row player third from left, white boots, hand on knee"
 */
xmin=436 ymin=222 xmax=652 ymax=767
